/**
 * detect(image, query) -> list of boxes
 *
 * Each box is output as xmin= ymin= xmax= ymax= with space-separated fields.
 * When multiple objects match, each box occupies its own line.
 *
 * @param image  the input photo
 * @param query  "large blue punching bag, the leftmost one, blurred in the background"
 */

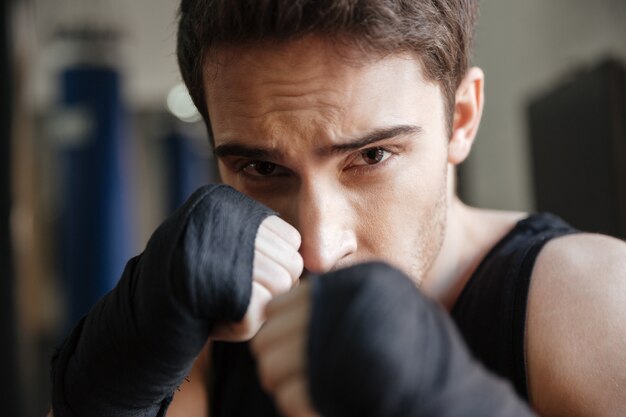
xmin=60 ymin=65 xmax=134 ymax=325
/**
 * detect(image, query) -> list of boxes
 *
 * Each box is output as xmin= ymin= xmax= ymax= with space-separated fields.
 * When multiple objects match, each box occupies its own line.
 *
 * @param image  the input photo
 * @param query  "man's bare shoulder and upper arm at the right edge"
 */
xmin=527 ymin=234 xmax=626 ymax=416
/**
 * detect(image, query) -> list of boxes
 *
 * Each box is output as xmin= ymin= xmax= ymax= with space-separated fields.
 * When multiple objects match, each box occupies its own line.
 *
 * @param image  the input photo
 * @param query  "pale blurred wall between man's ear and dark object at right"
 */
xmin=465 ymin=0 xmax=626 ymax=210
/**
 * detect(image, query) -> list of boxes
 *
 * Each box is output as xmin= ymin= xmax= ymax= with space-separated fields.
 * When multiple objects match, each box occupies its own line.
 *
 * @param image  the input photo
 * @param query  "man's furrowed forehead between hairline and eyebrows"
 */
xmin=205 ymin=38 xmax=438 ymax=153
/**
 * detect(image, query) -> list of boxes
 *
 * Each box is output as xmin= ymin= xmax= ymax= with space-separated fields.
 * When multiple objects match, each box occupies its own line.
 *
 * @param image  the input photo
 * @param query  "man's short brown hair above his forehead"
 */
xmin=177 ymin=0 xmax=479 ymax=140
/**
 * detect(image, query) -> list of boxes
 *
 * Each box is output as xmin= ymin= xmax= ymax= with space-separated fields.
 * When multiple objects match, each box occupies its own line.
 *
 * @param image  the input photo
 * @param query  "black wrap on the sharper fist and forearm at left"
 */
xmin=52 ymin=186 xmax=273 ymax=417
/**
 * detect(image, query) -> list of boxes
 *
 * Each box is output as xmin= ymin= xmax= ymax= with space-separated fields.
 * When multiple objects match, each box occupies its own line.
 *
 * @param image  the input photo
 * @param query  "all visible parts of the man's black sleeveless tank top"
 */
xmin=209 ymin=214 xmax=576 ymax=417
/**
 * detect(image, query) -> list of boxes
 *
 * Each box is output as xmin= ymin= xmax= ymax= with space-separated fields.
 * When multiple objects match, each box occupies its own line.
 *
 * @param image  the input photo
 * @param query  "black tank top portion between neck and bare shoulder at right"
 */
xmin=451 ymin=213 xmax=578 ymax=401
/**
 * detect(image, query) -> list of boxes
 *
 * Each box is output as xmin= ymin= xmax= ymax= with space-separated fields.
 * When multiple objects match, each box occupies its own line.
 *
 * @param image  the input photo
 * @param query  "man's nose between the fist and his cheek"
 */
xmin=294 ymin=184 xmax=357 ymax=273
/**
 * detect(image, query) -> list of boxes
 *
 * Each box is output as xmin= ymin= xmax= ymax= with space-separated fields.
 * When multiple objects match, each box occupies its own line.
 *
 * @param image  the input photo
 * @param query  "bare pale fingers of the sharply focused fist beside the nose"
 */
xmin=211 ymin=216 xmax=304 ymax=342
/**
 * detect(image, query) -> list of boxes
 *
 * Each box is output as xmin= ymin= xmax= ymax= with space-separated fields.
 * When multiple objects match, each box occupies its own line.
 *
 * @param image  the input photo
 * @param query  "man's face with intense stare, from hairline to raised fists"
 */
xmin=205 ymin=37 xmax=448 ymax=282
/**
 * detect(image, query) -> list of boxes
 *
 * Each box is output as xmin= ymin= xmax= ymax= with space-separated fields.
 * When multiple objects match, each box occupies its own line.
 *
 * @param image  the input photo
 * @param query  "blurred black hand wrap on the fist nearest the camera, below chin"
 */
xmin=308 ymin=263 xmax=533 ymax=417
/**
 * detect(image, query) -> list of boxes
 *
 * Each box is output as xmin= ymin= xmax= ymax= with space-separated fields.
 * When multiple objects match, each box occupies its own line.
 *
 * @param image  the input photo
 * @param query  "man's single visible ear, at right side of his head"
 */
xmin=448 ymin=67 xmax=485 ymax=165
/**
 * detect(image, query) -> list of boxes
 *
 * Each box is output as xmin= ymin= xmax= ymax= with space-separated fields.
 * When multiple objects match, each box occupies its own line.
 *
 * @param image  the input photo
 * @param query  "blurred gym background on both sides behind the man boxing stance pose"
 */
xmin=0 ymin=0 xmax=626 ymax=417
